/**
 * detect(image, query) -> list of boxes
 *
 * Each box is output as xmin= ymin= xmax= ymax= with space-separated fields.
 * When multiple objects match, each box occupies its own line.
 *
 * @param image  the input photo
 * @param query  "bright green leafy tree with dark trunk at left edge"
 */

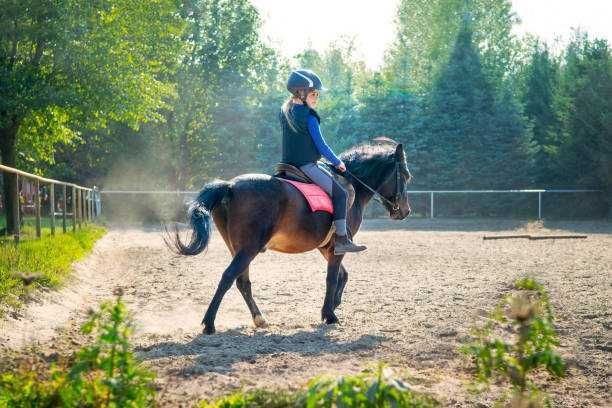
xmin=0 ymin=0 xmax=182 ymax=233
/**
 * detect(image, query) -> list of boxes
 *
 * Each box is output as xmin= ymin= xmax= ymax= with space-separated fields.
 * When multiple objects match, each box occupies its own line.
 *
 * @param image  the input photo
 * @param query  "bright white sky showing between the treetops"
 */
xmin=251 ymin=0 xmax=612 ymax=69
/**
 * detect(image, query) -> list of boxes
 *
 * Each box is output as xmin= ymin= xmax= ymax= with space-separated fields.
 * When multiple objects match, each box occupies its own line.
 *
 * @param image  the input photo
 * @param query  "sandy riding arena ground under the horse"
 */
xmin=0 ymin=220 xmax=612 ymax=407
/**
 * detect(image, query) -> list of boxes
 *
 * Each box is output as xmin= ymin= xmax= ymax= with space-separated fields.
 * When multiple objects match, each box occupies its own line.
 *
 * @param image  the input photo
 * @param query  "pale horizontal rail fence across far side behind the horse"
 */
xmin=100 ymin=189 xmax=601 ymax=220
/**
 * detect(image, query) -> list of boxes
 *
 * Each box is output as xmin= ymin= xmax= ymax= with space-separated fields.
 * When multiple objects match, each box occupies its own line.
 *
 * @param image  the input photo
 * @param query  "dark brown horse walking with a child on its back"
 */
xmin=165 ymin=138 xmax=411 ymax=334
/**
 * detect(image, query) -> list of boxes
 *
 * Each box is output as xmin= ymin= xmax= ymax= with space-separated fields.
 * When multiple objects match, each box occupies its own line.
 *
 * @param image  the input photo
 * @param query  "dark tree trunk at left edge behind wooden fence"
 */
xmin=0 ymin=120 xmax=19 ymax=235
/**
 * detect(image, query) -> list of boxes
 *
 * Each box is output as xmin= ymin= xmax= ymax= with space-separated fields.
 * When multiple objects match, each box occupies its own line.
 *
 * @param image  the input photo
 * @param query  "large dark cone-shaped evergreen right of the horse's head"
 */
xmin=416 ymin=18 xmax=531 ymax=189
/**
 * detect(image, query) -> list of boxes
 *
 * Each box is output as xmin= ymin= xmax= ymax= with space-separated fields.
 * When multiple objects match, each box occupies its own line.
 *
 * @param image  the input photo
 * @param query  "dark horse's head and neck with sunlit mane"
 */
xmin=341 ymin=137 xmax=411 ymax=220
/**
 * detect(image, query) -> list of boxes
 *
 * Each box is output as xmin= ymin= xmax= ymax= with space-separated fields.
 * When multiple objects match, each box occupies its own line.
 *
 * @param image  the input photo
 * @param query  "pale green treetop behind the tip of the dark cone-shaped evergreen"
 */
xmin=384 ymin=0 xmax=518 ymax=92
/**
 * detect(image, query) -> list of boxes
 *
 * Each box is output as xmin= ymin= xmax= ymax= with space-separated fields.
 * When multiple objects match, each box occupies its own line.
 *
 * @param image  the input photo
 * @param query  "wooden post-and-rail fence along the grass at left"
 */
xmin=0 ymin=164 xmax=100 ymax=242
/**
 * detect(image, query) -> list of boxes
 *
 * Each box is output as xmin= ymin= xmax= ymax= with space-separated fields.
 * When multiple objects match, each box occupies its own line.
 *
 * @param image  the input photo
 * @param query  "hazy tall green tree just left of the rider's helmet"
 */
xmin=154 ymin=0 xmax=281 ymax=189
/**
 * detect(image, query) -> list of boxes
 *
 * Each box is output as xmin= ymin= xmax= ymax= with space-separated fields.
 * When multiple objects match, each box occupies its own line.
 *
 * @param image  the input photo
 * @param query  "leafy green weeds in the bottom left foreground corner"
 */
xmin=0 ymin=294 xmax=155 ymax=407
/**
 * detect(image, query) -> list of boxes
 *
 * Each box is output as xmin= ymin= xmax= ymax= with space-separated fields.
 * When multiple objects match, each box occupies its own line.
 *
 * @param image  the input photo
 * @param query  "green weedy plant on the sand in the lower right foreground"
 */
xmin=461 ymin=278 xmax=565 ymax=406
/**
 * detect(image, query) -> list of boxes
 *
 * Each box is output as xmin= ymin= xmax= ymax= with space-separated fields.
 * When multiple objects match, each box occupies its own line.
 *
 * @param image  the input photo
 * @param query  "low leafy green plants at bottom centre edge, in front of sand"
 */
xmin=201 ymin=365 xmax=438 ymax=408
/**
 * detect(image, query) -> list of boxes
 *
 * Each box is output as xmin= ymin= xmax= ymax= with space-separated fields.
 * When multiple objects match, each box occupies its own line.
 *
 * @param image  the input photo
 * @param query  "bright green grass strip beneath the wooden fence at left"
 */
xmin=0 ymin=224 xmax=106 ymax=316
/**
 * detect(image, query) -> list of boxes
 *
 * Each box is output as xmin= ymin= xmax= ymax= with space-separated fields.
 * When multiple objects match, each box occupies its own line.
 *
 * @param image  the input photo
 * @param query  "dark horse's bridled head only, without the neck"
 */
xmin=378 ymin=143 xmax=412 ymax=220
